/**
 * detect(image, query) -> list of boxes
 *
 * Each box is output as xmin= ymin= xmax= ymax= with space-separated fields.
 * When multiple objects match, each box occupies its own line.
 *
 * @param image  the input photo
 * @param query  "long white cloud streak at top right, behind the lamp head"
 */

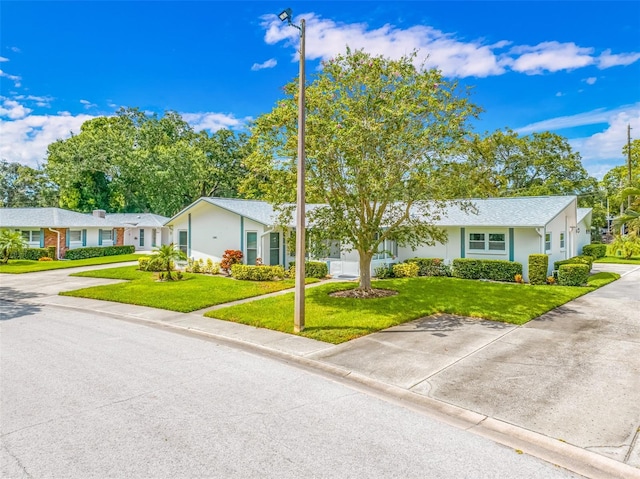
xmin=262 ymin=13 xmax=640 ymax=77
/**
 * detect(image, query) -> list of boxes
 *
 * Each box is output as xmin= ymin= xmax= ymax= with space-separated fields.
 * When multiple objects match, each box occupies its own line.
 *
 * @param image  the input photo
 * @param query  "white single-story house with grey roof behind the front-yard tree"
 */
xmin=165 ymin=196 xmax=591 ymax=279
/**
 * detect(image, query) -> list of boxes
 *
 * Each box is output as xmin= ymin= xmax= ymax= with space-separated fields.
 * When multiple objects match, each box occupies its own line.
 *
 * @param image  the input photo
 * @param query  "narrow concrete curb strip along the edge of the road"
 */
xmin=32 ymin=303 xmax=640 ymax=479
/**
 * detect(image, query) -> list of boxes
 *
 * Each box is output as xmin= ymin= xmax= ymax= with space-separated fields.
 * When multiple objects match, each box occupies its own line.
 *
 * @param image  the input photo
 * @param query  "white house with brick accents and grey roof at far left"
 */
xmin=0 ymin=208 xmax=169 ymax=258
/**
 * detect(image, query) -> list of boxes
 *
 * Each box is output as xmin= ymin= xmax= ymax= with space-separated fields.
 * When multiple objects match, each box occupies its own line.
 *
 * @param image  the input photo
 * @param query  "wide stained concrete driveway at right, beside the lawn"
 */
xmin=313 ymin=264 xmax=640 ymax=467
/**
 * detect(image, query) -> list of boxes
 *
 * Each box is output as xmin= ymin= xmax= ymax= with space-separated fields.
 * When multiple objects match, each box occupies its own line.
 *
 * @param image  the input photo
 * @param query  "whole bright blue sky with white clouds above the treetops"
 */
xmin=0 ymin=0 xmax=640 ymax=177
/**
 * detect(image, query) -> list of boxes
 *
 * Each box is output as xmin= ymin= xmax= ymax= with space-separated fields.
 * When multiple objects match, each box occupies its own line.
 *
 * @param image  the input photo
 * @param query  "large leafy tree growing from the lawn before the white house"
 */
xmin=246 ymin=50 xmax=477 ymax=292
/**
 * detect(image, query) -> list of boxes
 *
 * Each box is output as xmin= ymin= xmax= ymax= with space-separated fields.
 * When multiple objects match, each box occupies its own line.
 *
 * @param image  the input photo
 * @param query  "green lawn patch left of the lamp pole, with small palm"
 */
xmin=60 ymin=266 xmax=318 ymax=313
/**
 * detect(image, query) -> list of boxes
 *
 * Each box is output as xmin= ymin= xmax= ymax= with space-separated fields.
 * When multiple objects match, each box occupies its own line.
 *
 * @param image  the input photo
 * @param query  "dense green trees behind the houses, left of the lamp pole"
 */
xmin=46 ymin=108 xmax=246 ymax=216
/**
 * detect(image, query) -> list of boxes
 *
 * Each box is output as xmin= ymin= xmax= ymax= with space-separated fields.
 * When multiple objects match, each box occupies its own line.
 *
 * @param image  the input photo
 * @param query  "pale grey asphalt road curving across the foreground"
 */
xmin=0 ymin=300 xmax=576 ymax=479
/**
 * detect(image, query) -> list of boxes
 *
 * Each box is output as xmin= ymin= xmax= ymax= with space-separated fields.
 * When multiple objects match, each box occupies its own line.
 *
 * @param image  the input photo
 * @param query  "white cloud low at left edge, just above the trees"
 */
xmin=0 ymin=114 xmax=94 ymax=167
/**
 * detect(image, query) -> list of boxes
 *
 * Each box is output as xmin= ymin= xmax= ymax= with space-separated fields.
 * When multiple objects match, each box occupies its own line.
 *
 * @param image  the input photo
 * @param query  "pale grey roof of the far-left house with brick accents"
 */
xmin=0 ymin=208 xmax=166 ymax=228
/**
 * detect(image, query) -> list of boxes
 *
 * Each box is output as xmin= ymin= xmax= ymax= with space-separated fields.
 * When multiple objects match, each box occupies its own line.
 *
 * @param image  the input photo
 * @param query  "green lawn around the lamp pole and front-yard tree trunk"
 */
xmin=206 ymin=273 xmax=620 ymax=344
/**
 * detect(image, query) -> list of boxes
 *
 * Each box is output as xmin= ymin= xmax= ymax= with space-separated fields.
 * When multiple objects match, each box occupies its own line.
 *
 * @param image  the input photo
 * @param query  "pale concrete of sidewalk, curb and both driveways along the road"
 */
xmin=0 ymin=264 xmax=640 ymax=478
